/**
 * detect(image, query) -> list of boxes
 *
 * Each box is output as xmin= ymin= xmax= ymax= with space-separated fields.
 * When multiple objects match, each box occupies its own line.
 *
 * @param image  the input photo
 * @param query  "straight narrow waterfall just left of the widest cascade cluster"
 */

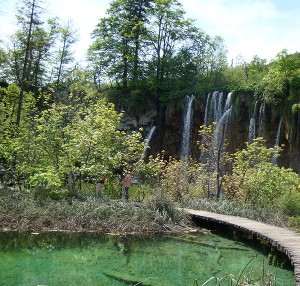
xmin=181 ymin=95 xmax=195 ymax=158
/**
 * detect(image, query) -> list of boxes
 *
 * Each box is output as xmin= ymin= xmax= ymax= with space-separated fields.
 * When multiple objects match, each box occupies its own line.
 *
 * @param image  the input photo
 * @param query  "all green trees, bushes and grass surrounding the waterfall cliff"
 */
xmin=0 ymin=0 xmax=300 ymax=235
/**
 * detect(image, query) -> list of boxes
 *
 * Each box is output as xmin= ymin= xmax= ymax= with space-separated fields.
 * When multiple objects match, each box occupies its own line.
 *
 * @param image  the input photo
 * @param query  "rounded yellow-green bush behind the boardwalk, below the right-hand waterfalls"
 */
xmin=224 ymin=138 xmax=300 ymax=208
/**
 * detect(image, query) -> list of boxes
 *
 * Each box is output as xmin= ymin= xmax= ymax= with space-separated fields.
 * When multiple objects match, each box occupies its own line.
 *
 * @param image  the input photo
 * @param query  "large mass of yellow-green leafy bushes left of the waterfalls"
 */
xmin=0 ymin=80 xmax=144 ymax=197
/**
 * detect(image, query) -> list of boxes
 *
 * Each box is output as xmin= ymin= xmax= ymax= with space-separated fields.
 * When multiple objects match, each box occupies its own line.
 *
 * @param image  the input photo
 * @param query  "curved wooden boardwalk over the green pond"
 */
xmin=183 ymin=209 xmax=300 ymax=286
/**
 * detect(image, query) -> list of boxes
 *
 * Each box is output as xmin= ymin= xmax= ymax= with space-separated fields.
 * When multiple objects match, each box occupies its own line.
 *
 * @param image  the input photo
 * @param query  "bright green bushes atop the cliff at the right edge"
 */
xmin=223 ymin=50 xmax=300 ymax=110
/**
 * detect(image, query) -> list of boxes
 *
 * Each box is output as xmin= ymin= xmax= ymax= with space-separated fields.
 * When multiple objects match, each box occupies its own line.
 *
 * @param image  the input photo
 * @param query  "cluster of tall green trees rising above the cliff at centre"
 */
xmin=88 ymin=0 xmax=227 ymax=105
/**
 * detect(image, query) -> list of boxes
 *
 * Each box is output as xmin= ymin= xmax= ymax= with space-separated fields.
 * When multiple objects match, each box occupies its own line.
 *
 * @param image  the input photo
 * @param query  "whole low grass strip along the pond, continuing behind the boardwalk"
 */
xmin=0 ymin=185 xmax=299 ymax=233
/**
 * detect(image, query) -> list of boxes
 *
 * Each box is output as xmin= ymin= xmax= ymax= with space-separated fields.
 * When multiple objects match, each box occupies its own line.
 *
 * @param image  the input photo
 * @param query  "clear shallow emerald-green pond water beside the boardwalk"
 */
xmin=0 ymin=233 xmax=295 ymax=286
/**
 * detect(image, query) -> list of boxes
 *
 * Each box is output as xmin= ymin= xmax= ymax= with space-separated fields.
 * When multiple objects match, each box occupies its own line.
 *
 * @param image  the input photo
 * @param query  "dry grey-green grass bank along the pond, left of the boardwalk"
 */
xmin=0 ymin=190 xmax=189 ymax=233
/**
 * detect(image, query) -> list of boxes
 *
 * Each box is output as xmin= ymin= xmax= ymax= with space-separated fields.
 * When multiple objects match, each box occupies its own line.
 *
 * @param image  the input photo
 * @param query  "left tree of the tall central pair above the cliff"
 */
xmin=89 ymin=0 xmax=152 ymax=89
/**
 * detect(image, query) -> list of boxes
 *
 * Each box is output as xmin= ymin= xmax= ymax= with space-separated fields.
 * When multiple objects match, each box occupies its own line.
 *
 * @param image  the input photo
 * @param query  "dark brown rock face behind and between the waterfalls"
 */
xmin=120 ymin=94 xmax=300 ymax=173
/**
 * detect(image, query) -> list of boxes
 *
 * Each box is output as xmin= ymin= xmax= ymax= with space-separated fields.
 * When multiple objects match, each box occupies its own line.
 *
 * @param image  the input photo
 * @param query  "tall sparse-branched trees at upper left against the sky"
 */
xmin=10 ymin=0 xmax=76 ymax=118
